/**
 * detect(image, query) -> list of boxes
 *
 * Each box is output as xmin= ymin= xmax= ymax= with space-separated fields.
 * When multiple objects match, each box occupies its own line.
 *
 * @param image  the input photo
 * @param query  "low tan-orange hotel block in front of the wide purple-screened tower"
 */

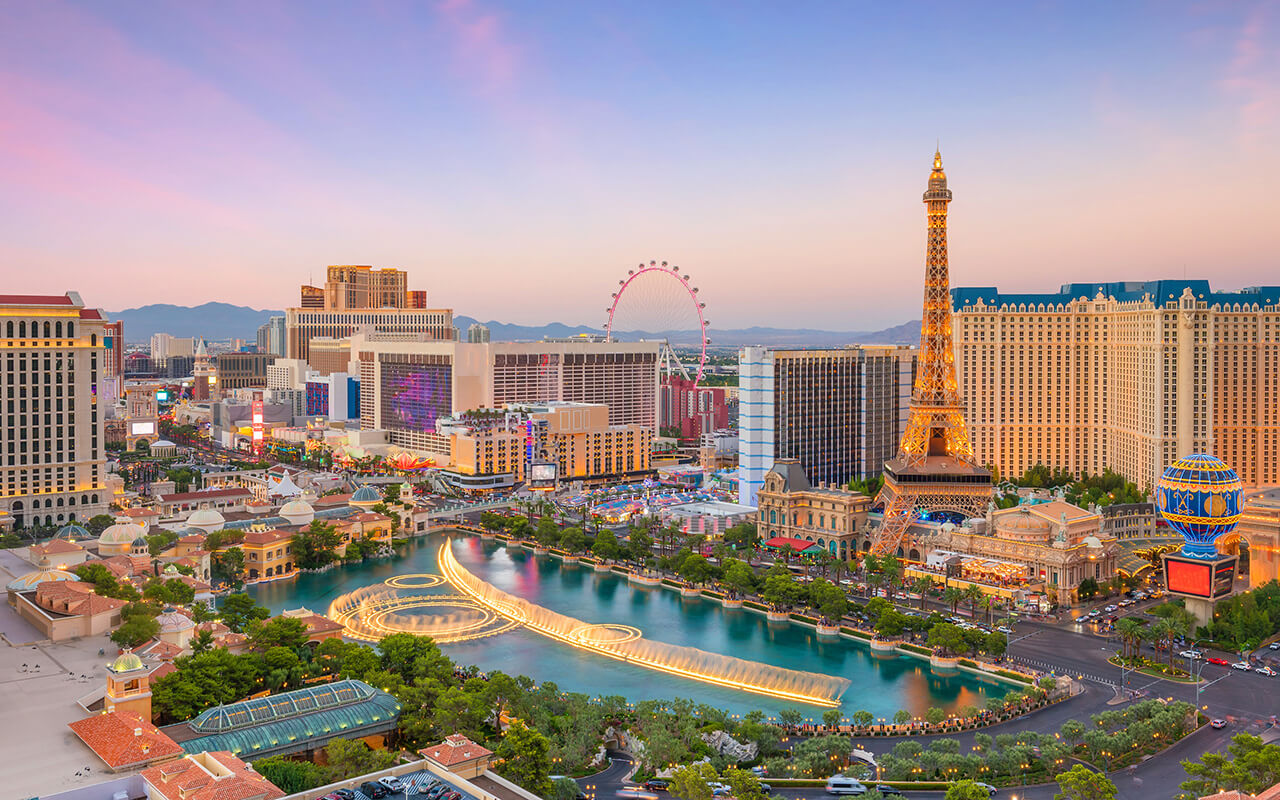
xmin=436 ymin=403 xmax=653 ymax=489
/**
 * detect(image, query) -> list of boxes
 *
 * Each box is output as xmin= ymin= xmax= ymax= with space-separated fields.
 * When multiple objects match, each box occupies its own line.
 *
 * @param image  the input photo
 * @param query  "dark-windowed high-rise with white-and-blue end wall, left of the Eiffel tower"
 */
xmin=737 ymin=344 xmax=916 ymax=506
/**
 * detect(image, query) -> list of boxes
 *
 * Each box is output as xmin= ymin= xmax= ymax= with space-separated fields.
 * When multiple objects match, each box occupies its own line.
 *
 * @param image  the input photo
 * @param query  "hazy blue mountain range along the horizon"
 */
xmin=106 ymin=302 xmax=920 ymax=347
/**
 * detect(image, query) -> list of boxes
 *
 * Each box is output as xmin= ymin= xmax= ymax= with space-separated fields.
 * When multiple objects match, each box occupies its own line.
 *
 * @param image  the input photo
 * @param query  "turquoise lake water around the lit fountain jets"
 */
xmin=248 ymin=535 xmax=1010 ymax=718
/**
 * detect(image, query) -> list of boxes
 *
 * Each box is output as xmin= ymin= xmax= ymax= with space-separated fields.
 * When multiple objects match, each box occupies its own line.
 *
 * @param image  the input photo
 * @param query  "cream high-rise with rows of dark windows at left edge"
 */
xmin=0 ymin=292 xmax=113 ymax=527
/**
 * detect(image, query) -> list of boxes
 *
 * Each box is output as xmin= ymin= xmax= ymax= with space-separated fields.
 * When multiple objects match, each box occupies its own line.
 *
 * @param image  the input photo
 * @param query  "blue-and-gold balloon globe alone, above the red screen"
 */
xmin=1156 ymin=453 xmax=1240 ymax=558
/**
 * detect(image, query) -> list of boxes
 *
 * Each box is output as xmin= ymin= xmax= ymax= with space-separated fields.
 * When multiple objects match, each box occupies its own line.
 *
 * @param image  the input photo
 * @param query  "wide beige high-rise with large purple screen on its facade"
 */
xmin=352 ymin=334 xmax=660 ymax=453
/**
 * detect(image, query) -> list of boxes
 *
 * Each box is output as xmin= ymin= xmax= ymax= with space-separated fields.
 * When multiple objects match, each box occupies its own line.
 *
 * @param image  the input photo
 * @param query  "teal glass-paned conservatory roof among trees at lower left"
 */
xmin=164 ymin=680 xmax=401 ymax=758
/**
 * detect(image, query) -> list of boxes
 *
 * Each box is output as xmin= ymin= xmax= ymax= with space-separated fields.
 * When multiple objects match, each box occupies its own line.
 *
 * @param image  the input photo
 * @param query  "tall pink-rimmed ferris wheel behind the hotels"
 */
xmin=604 ymin=261 xmax=710 ymax=383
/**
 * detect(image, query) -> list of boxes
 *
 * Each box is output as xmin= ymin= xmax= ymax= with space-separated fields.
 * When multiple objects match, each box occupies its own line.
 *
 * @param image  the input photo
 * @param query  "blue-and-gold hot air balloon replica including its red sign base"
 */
xmin=1156 ymin=453 xmax=1240 ymax=625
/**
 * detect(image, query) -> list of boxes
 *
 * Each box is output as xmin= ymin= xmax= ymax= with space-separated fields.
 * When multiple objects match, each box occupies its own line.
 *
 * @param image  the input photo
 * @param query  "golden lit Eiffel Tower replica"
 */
xmin=872 ymin=152 xmax=991 ymax=556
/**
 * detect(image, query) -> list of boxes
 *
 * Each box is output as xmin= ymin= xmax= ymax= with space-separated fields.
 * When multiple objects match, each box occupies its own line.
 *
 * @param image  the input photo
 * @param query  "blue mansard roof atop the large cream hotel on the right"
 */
xmin=951 ymin=280 xmax=1280 ymax=311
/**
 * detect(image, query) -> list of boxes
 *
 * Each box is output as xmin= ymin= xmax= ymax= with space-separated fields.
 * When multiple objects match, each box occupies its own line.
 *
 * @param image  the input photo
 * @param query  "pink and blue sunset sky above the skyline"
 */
xmin=0 ymin=0 xmax=1280 ymax=330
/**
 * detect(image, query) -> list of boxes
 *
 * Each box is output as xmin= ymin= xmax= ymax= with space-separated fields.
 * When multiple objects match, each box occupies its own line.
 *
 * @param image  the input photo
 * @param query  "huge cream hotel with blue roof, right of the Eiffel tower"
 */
xmin=952 ymin=280 xmax=1280 ymax=489
